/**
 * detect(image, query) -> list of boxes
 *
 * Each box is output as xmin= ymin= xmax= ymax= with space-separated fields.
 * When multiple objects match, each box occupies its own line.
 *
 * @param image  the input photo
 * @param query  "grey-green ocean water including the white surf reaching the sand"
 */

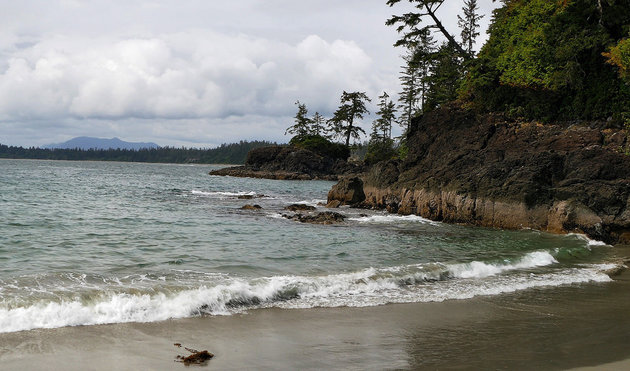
xmin=0 ymin=160 xmax=616 ymax=332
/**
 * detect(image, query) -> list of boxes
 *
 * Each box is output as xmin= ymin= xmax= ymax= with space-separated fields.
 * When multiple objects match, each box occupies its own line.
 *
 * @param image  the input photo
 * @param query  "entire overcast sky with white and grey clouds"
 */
xmin=0 ymin=0 xmax=502 ymax=147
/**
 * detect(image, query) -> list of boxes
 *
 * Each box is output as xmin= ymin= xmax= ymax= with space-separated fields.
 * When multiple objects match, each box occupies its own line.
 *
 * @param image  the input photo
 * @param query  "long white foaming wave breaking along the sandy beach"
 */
xmin=0 ymin=252 xmax=612 ymax=332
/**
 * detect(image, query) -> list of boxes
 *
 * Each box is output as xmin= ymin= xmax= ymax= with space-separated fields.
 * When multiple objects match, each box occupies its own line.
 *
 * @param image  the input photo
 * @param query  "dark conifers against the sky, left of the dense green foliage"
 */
xmin=285 ymin=0 xmax=482 ymax=163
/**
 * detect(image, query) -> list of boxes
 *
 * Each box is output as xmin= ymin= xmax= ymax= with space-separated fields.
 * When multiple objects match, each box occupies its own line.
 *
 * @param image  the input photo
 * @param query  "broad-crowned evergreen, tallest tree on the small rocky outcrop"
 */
xmin=328 ymin=91 xmax=371 ymax=147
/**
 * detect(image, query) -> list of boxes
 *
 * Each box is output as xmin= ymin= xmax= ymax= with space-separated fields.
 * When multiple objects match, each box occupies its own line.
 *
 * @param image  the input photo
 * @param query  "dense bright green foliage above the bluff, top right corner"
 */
xmin=461 ymin=0 xmax=630 ymax=120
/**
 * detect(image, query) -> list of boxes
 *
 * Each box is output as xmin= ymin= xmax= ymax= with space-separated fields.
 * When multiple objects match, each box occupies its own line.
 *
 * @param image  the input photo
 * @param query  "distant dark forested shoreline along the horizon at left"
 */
xmin=0 ymin=140 xmax=277 ymax=164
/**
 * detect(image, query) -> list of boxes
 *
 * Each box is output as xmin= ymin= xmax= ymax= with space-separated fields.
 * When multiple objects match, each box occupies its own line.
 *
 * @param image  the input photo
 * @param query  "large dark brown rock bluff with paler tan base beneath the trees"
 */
xmin=354 ymin=107 xmax=630 ymax=243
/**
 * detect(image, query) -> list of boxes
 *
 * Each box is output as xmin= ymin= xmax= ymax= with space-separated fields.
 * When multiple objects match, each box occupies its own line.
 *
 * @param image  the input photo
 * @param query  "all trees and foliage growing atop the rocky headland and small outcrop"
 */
xmin=287 ymin=0 xmax=630 ymax=164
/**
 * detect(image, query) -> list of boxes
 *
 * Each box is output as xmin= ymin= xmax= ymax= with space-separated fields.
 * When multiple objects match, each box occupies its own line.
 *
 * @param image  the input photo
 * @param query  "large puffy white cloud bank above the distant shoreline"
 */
xmin=0 ymin=31 xmax=379 ymax=121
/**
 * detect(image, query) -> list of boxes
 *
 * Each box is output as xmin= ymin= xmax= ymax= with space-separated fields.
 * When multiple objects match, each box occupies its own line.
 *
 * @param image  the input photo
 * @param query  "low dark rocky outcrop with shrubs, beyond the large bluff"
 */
xmin=210 ymin=146 xmax=361 ymax=180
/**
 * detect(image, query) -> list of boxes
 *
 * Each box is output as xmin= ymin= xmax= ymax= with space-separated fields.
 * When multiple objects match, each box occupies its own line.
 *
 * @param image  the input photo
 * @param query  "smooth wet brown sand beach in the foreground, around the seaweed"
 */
xmin=0 ymin=272 xmax=630 ymax=370
